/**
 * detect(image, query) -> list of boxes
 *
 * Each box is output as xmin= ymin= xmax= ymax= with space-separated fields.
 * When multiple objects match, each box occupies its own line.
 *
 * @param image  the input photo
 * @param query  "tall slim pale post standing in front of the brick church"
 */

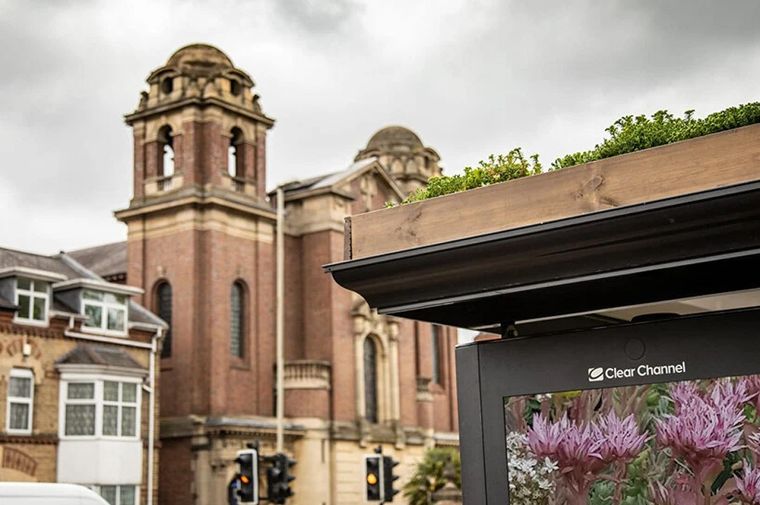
xmin=275 ymin=188 xmax=285 ymax=452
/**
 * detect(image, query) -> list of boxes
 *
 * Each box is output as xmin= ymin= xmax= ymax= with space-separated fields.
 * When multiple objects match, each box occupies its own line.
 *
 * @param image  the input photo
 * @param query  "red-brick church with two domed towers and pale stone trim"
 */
xmin=71 ymin=44 xmax=457 ymax=505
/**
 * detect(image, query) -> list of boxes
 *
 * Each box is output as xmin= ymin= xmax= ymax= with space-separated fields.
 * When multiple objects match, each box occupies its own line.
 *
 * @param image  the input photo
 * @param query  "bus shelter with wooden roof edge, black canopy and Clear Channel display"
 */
xmin=326 ymin=125 xmax=760 ymax=505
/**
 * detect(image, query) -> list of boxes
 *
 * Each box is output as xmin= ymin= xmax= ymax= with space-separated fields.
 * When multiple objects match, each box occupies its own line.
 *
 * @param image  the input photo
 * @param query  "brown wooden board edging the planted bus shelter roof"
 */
xmin=346 ymin=124 xmax=760 ymax=259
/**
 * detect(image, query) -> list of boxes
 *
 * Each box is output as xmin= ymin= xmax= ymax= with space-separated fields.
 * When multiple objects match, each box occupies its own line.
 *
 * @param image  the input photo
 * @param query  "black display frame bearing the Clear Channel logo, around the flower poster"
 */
xmin=456 ymin=309 xmax=760 ymax=505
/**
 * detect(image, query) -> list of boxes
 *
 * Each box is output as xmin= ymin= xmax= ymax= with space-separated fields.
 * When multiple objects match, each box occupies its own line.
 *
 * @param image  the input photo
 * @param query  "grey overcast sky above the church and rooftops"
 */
xmin=0 ymin=0 xmax=760 ymax=253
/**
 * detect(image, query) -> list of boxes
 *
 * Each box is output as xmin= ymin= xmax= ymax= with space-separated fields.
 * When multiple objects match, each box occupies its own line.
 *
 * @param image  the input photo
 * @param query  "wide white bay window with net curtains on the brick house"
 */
xmin=61 ymin=380 xmax=140 ymax=439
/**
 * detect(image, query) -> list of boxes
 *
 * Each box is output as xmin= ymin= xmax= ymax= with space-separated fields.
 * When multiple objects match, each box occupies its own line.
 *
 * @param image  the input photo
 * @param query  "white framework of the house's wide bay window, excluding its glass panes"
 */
xmin=58 ymin=374 xmax=143 ymax=441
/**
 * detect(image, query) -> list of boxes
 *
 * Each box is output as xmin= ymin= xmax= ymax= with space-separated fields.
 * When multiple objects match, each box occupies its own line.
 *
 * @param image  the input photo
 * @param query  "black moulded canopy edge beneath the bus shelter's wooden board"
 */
xmin=324 ymin=182 xmax=760 ymax=332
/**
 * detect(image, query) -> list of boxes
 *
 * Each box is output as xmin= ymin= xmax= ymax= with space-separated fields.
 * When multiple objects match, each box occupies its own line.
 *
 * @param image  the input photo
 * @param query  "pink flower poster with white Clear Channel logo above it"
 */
xmin=500 ymin=372 xmax=760 ymax=505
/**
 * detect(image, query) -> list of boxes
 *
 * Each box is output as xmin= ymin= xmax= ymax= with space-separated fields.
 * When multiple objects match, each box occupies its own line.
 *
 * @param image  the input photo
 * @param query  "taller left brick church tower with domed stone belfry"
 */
xmin=116 ymin=44 xmax=275 ymax=503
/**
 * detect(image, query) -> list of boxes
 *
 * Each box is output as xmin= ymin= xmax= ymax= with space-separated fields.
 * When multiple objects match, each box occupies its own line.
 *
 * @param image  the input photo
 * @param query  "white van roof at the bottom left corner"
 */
xmin=0 ymin=482 xmax=108 ymax=505
